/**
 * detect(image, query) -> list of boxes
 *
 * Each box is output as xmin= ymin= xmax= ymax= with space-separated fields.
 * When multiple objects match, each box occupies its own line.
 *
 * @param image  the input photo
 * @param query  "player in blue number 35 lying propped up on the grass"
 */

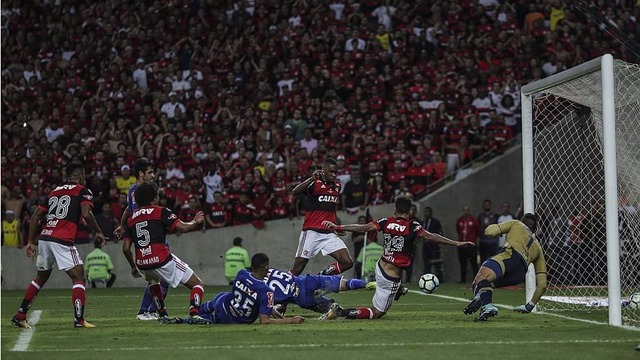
xmin=158 ymin=253 xmax=304 ymax=324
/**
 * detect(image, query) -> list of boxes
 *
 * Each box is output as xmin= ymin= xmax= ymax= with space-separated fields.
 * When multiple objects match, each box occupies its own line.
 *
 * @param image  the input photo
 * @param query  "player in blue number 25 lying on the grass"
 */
xmin=264 ymin=268 xmax=376 ymax=313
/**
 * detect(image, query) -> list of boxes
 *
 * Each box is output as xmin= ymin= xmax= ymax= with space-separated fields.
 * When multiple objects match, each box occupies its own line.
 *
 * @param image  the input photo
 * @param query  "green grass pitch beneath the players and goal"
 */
xmin=1 ymin=284 xmax=640 ymax=360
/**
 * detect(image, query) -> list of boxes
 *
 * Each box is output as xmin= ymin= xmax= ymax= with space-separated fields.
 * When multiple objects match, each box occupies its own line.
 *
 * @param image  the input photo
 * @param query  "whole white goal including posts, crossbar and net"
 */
xmin=521 ymin=54 xmax=640 ymax=325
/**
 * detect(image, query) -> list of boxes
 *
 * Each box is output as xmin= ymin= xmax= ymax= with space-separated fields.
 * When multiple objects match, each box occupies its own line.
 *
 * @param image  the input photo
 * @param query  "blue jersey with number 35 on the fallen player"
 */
xmin=210 ymin=269 xmax=274 ymax=324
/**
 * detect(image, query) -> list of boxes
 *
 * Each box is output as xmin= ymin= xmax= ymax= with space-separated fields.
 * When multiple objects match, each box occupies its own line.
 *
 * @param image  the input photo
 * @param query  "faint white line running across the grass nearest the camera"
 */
xmin=25 ymin=339 xmax=638 ymax=352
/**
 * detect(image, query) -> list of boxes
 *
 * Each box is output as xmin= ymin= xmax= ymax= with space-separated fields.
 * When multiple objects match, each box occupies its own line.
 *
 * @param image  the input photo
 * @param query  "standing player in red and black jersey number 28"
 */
xmin=11 ymin=163 xmax=106 ymax=329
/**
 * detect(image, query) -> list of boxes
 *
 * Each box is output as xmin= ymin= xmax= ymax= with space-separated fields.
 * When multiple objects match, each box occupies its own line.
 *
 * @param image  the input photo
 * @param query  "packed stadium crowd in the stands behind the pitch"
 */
xmin=1 ymin=0 xmax=640 ymax=242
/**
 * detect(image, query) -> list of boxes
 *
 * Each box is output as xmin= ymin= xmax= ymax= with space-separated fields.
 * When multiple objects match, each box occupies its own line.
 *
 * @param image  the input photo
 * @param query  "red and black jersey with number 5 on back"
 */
xmin=124 ymin=205 xmax=180 ymax=270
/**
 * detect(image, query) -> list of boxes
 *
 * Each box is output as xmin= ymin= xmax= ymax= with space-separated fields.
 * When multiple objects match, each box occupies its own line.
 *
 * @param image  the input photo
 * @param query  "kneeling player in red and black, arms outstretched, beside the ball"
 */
xmin=320 ymin=195 xmax=475 ymax=320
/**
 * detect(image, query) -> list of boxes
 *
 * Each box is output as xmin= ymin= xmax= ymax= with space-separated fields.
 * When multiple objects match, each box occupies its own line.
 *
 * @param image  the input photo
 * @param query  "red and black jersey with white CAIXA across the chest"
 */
xmin=302 ymin=180 xmax=340 ymax=233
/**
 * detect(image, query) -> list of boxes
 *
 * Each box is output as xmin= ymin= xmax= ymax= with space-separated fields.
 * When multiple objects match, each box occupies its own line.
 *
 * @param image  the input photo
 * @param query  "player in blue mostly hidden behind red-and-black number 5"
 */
xmin=114 ymin=157 xmax=169 ymax=320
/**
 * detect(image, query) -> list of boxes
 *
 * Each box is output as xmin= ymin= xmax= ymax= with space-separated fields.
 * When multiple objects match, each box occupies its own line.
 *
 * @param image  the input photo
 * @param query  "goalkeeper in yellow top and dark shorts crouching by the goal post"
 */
xmin=464 ymin=214 xmax=547 ymax=321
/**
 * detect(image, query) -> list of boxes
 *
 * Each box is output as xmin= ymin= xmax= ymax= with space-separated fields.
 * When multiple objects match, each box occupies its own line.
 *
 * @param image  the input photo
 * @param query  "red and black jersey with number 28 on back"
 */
xmin=38 ymin=184 xmax=93 ymax=245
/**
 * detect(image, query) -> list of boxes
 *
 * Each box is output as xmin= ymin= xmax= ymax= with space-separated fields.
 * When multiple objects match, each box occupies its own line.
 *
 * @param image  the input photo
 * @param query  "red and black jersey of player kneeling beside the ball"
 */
xmin=374 ymin=217 xmax=425 ymax=268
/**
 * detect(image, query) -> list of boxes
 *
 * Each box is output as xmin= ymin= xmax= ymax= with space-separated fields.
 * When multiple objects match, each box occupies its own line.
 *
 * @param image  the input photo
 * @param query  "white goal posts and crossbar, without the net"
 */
xmin=520 ymin=54 xmax=622 ymax=326
